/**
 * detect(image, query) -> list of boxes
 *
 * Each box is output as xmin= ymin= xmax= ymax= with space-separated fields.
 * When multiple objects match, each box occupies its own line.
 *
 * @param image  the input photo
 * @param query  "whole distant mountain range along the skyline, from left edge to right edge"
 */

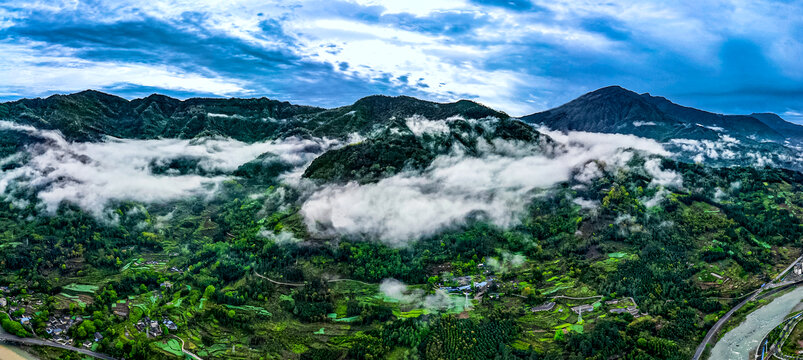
xmin=0 ymin=86 xmax=803 ymax=169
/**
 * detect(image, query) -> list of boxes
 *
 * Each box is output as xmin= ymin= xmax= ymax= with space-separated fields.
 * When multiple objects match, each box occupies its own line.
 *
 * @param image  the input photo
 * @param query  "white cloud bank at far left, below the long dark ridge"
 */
xmin=0 ymin=121 xmax=334 ymax=217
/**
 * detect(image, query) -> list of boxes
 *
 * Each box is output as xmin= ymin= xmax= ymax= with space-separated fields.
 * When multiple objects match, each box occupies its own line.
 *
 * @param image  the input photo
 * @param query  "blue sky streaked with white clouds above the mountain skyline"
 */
xmin=0 ymin=0 xmax=803 ymax=122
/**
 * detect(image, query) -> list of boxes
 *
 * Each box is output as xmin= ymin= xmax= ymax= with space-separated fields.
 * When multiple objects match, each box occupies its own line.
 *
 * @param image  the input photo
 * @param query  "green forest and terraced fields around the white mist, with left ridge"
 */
xmin=0 ymin=92 xmax=803 ymax=359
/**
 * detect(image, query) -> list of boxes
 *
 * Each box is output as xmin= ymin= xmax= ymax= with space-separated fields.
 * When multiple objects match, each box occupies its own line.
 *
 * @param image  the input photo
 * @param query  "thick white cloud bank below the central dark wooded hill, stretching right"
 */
xmin=301 ymin=129 xmax=669 ymax=245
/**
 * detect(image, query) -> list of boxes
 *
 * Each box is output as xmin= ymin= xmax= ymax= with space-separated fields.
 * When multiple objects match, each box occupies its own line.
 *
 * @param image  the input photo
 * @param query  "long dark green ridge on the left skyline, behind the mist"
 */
xmin=0 ymin=90 xmax=508 ymax=141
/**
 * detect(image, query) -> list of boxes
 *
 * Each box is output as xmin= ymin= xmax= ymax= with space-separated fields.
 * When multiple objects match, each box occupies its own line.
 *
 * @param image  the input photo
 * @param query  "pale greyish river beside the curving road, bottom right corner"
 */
xmin=708 ymin=286 xmax=803 ymax=360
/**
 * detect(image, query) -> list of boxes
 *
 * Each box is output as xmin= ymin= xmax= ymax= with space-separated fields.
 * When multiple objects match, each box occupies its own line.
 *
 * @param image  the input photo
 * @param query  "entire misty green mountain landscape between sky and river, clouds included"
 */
xmin=0 ymin=87 xmax=803 ymax=359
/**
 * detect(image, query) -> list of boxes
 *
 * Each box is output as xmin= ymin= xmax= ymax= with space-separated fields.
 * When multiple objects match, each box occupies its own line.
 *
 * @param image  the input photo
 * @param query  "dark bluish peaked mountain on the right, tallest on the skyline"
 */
xmin=520 ymin=86 xmax=803 ymax=170
